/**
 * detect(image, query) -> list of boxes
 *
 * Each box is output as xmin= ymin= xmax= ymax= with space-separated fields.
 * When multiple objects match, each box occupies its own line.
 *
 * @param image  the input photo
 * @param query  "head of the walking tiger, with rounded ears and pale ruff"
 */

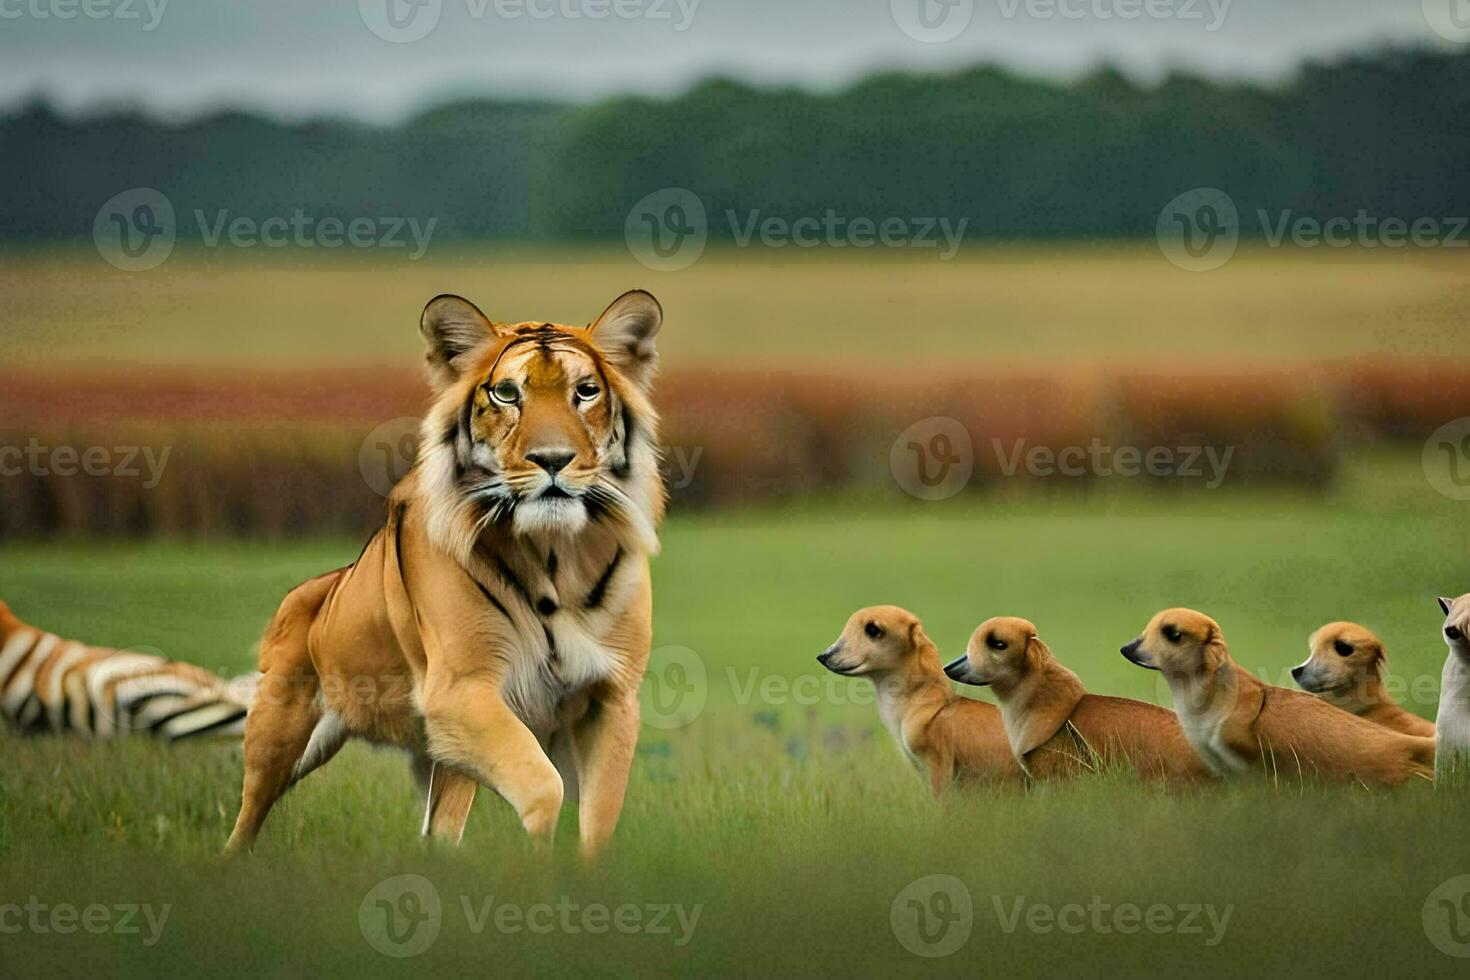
xmin=420 ymin=289 xmax=663 ymax=560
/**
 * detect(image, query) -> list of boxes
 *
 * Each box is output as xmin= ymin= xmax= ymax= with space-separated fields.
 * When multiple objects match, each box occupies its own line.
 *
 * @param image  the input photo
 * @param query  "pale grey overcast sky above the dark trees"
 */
xmin=0 ymin=0 xmax=1470 ymax=122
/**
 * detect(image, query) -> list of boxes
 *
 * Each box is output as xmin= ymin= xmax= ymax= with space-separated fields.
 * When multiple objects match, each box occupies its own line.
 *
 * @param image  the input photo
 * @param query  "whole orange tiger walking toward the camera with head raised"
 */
xmin=225 ymin=289 xmax=666 ymax=857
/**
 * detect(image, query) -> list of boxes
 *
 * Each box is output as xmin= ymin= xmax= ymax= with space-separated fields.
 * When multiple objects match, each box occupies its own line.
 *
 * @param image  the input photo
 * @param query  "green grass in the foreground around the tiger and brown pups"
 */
xmin=0 ymin=460 xmax=1470 ymax=976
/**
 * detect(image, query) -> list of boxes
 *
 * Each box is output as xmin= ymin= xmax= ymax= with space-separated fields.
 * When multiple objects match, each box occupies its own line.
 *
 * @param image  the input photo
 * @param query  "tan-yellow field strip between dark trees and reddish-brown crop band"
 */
xmin=0 ymin=244 xmax=1470 ymax=370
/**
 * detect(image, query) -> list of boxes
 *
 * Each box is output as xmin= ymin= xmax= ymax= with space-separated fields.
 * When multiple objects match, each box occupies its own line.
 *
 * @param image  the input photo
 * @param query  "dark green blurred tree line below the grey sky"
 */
xmin=0 ymin=50 xmax=1470 ymax=241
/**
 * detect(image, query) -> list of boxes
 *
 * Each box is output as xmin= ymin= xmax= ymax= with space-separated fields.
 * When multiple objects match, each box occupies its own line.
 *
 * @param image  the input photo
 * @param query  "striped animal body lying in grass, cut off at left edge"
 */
xmin=0 ymin=602 xmax=253 ymax=742
